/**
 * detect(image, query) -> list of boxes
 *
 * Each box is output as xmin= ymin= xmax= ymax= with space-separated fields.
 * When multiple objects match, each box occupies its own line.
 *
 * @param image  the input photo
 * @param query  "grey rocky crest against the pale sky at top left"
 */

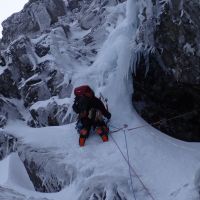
xmin=2 ymin=0 xmax=66 ymax=44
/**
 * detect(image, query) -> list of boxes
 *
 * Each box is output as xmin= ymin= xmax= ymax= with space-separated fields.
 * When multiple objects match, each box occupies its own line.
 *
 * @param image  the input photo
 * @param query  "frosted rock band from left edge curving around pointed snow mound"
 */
xmin=0 ymin=132 xmax=77 ymax=194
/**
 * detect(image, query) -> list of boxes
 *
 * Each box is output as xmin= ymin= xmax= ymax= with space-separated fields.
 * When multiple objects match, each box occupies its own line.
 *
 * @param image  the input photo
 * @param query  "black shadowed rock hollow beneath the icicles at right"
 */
xmin=133 ymin=51 xmax=200 ymax=141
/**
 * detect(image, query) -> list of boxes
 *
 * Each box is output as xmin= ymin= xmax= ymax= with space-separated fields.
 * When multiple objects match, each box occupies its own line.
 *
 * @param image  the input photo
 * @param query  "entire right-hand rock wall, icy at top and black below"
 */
xmin=133 ymin=0 xmax=200 ymax=141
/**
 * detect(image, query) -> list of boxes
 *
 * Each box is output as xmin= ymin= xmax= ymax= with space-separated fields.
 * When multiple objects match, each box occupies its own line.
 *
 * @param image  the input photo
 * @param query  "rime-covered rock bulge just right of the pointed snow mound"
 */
xmin=18 ymin=145 xmax=77 ymax=193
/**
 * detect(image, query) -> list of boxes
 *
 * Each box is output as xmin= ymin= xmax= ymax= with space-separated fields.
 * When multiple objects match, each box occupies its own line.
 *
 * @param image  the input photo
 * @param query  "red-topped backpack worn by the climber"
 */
xmin=72 ymin=85 xmax=95 ymax=113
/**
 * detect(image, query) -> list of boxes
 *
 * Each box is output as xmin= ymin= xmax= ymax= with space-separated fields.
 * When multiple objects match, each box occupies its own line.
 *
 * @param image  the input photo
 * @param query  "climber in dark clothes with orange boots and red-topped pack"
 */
xmin=72 ymin=85 xmax=111 ymax=147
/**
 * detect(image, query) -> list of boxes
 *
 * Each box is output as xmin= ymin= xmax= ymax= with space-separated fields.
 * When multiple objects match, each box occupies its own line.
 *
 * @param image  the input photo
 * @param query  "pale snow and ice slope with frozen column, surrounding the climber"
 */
xmin=0 ymin=0 xmax=200 ymax=200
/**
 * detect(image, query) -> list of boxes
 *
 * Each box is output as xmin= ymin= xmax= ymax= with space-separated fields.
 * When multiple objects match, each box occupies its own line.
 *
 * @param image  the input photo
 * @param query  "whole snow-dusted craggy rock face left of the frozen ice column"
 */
xmin=0 ymin=0 xmax=125 ymax=127
